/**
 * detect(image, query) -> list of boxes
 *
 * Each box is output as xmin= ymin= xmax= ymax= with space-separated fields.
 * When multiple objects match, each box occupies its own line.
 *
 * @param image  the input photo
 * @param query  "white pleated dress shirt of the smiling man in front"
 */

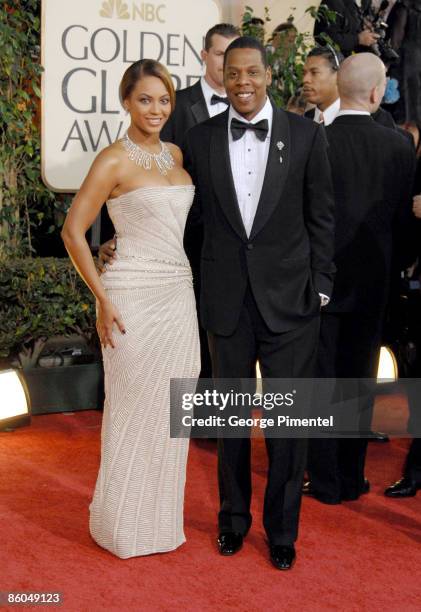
xmin=228 ymin=98 xmax=273 ymax=236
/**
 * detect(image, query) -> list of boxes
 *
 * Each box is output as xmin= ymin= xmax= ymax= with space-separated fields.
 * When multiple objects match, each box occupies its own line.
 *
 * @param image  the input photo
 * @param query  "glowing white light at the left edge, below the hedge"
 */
xmin=0 ymin=370 xmax=30 ymax=430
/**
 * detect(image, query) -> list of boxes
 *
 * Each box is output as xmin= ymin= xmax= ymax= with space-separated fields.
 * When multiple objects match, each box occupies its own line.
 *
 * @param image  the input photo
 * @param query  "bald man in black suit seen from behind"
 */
xmin=303 ymin=53 xmax=415 ymax=504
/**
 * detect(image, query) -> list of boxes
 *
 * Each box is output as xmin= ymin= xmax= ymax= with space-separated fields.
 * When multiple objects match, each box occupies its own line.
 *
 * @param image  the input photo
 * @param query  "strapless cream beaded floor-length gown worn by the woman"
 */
xmin=90 ymin=185 xmax=200 ymax=558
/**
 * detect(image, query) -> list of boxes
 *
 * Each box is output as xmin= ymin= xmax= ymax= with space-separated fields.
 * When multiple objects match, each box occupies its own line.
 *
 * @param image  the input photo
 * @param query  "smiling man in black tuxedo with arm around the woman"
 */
xmin=184 ymin=37 xmax=334 ymax=569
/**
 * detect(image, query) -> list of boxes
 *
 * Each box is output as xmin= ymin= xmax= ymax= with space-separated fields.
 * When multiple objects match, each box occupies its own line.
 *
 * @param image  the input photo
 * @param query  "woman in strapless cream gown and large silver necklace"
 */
xmin=63 ymin=60 xmax=200 ymax=558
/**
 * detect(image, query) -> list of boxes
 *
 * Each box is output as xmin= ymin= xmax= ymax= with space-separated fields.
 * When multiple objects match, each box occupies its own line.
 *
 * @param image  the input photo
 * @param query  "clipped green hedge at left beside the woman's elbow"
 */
xmin=0 ymin=258 xmax=95 ymax=365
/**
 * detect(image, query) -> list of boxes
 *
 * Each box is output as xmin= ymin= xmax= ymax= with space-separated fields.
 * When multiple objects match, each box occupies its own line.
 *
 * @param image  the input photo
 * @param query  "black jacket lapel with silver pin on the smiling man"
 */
xmin=250 ymin=107 xmax=291 ymax=239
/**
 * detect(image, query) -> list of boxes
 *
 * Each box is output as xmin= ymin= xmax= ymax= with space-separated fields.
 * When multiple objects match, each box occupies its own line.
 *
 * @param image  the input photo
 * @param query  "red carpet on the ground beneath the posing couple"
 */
xmin=0 ymin=404 xmax=421 ymax=612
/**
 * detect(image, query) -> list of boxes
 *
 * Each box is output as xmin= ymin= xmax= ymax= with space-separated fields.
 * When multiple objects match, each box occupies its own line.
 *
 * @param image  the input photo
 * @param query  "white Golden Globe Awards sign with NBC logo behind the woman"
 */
xmin=42 ymin=0 xmax=222 ymax=192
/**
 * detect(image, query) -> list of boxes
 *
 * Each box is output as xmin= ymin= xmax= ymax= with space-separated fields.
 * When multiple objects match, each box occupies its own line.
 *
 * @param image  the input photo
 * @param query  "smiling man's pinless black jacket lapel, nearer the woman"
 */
xmin=209 ymin=109 xmax=247 ymax=240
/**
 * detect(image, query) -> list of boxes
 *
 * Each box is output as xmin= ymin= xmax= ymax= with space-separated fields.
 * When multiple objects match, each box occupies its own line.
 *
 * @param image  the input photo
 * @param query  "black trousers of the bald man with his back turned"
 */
xmin=307 ymin=313 xmax=382 ymax=503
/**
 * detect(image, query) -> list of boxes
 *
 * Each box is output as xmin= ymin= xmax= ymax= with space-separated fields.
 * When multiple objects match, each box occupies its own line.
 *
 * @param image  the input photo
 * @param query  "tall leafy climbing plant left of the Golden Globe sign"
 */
xmin=0 ymin=0 xmax=67 ymax=261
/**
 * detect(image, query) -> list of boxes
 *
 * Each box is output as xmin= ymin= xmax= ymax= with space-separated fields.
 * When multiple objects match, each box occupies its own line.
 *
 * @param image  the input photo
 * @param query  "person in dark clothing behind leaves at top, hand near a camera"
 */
xmin=313 ymin=0 xmax=379 ymax=56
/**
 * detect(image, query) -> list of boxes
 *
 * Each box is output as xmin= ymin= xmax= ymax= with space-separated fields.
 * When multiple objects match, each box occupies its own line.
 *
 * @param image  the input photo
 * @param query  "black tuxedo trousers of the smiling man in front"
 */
xmin=209 ymin=287 xmax=320 ymax=545
